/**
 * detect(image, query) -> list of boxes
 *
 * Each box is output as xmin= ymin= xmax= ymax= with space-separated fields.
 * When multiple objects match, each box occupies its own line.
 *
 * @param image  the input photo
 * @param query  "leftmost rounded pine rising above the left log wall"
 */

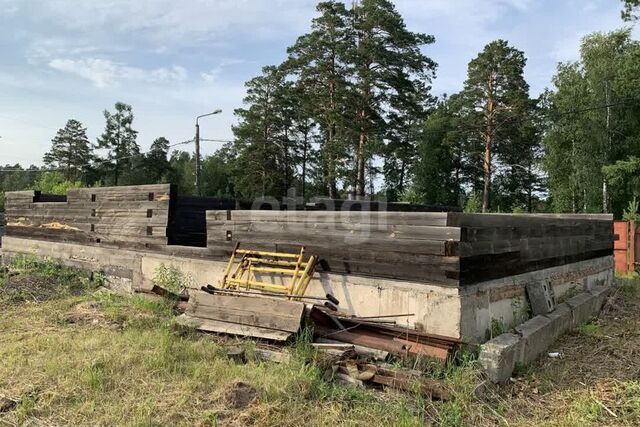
xmin=43 ymin=119 xmax=93 ymax=181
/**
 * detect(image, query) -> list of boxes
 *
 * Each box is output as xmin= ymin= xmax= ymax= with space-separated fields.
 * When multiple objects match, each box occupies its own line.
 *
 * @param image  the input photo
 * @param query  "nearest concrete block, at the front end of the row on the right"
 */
xmin=478 ymin=333 xmax=522 ymax=383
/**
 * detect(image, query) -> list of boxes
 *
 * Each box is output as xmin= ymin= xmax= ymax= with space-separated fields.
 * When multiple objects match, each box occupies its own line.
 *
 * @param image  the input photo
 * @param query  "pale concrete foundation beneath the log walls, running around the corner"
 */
xmin=2 ymin=236 xmax=613 ymax=344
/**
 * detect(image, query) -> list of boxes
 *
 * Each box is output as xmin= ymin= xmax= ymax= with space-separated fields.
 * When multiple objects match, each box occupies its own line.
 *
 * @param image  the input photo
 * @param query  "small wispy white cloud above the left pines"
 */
xmin=49 ymin=58 xmax=187 ymax=88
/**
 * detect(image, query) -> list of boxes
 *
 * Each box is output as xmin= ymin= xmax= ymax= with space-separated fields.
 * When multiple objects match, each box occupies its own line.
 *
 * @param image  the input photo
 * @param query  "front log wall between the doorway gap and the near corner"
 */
xmin=207 ymin=210 xmax=460 ymax=286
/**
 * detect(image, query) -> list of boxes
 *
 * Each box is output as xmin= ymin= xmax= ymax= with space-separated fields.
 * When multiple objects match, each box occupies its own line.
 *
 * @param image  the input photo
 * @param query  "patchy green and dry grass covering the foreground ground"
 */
xmin=0 ymin=260 xmax=640 ymax=427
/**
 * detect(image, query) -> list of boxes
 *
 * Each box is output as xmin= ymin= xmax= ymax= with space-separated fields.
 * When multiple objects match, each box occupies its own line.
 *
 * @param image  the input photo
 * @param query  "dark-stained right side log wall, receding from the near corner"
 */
xmin=447 ymin=212 xmax=614 ymax=285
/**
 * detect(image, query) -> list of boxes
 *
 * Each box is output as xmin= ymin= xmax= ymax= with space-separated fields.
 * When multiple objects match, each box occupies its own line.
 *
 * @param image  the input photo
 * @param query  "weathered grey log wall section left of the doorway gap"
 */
xmin=6 ymin=184 xmax=170 ymax=248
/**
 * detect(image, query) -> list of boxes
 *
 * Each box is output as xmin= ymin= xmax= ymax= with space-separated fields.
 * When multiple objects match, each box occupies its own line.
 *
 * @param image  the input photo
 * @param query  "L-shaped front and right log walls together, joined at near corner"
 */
xmin=207 ymin=210 xmax=614 ymax=286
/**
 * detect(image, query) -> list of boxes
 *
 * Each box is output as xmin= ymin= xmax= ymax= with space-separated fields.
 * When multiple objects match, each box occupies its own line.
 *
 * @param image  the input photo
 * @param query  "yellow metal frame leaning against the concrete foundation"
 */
xmin=220 ymin=244 xmax=317 ymax=298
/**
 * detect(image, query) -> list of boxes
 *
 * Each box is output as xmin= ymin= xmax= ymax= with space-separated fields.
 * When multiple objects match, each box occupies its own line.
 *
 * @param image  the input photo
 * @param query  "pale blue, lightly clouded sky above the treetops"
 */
xmin=0 ymin=0 xmax=639 ymax=166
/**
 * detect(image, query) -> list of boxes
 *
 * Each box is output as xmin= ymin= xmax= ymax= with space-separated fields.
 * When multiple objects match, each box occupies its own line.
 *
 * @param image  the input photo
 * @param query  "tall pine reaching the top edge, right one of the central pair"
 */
xmin=351 ymin=0 xmax=436 ymax=198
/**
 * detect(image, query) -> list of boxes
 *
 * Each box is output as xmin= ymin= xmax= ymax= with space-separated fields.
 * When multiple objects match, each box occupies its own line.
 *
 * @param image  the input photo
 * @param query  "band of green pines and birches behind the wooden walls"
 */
xmin=0 ymin=0 xmax=640 ymax=217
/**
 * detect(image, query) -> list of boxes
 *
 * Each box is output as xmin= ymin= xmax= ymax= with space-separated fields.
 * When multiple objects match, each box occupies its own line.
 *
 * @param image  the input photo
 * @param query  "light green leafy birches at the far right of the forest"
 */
xmin=544 ymin=30 xmax=640 ymax=217
